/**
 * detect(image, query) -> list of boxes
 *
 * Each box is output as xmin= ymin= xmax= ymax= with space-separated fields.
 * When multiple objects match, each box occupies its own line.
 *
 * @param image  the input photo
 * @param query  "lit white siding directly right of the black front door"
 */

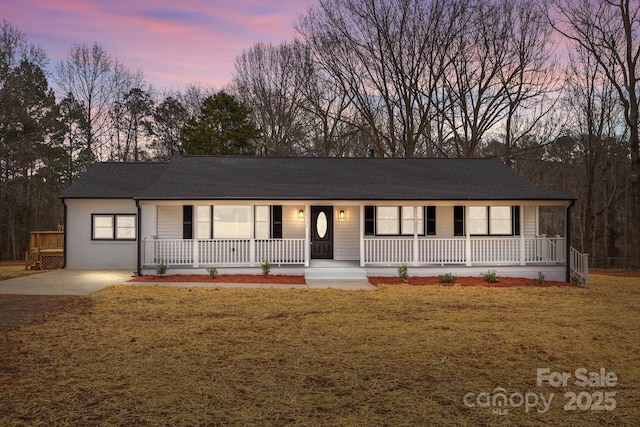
xmin=333 ymin=206 xmax=360 ymax=261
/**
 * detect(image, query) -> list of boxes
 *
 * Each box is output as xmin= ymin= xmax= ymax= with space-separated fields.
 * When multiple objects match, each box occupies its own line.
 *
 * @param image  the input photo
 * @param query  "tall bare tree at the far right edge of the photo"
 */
xmin=551 ymin=0 xmax=640 ymax=268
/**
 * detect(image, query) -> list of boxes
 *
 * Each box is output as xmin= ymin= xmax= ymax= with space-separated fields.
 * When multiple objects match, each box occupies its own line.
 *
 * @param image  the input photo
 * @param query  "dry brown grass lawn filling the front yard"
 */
xmin=0 ymin=275 xmax=640 ymax=426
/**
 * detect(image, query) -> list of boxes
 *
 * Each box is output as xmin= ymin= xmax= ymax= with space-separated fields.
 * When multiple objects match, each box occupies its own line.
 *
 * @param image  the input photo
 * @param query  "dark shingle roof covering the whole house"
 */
xmin=63 ymin=156 xmax=571 ymax=200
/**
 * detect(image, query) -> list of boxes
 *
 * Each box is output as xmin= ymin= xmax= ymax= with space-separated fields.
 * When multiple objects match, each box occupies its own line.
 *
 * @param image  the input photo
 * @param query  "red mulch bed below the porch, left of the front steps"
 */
xmin=129 ymin=274 xmax=306 ymax=285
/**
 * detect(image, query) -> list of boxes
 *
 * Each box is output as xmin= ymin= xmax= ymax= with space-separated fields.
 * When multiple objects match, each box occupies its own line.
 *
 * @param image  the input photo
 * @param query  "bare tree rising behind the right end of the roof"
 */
xmin=437 ymin=0 xmax=554 ymax=159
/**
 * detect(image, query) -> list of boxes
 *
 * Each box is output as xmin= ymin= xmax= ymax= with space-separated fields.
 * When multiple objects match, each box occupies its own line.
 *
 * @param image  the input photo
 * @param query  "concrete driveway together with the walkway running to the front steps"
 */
xmin=0 ymin=269 xmax=376 ymax=295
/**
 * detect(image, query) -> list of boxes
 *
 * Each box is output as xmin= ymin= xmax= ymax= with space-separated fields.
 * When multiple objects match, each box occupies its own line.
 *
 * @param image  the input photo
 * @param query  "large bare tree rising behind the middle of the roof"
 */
xmin=296 ymin=0 xmax=458 ymax=157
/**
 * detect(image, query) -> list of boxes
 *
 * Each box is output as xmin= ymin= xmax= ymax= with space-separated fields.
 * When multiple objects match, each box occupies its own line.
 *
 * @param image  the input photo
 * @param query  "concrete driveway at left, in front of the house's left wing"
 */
xmin=0 ymin=269 xmax=133 ymax=295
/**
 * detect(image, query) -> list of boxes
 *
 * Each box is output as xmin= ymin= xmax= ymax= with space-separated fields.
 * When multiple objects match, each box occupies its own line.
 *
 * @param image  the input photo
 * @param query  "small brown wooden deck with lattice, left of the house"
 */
xmin=24 ymin=229 xmax=64 ymax=270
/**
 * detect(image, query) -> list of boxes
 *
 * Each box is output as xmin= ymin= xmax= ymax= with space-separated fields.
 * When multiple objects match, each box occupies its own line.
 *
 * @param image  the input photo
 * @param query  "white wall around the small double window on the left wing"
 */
xmin=65 ymin=199 xmax=137 ymax=270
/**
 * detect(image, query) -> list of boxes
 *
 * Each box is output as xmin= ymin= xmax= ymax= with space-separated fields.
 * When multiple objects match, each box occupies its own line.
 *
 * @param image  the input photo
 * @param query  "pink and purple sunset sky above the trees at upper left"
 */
xmin=0 ymin=0 xmax=317 ymax=89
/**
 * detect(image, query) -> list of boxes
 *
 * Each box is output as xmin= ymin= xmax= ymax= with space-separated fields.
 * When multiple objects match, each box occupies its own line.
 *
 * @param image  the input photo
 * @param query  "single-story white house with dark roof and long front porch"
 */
xmin=61 ymin=156 xmax=575 ymax=280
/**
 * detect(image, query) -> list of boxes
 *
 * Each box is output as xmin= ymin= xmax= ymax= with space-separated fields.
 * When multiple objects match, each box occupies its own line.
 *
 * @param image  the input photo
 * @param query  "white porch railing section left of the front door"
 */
xmin=143 ymin=239 xmax=305 ymax=266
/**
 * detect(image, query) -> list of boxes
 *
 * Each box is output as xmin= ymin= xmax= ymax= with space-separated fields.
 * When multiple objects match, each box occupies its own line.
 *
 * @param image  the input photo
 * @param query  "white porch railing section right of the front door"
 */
xmin=364 ymin=237 xmax=566 ymax=265
